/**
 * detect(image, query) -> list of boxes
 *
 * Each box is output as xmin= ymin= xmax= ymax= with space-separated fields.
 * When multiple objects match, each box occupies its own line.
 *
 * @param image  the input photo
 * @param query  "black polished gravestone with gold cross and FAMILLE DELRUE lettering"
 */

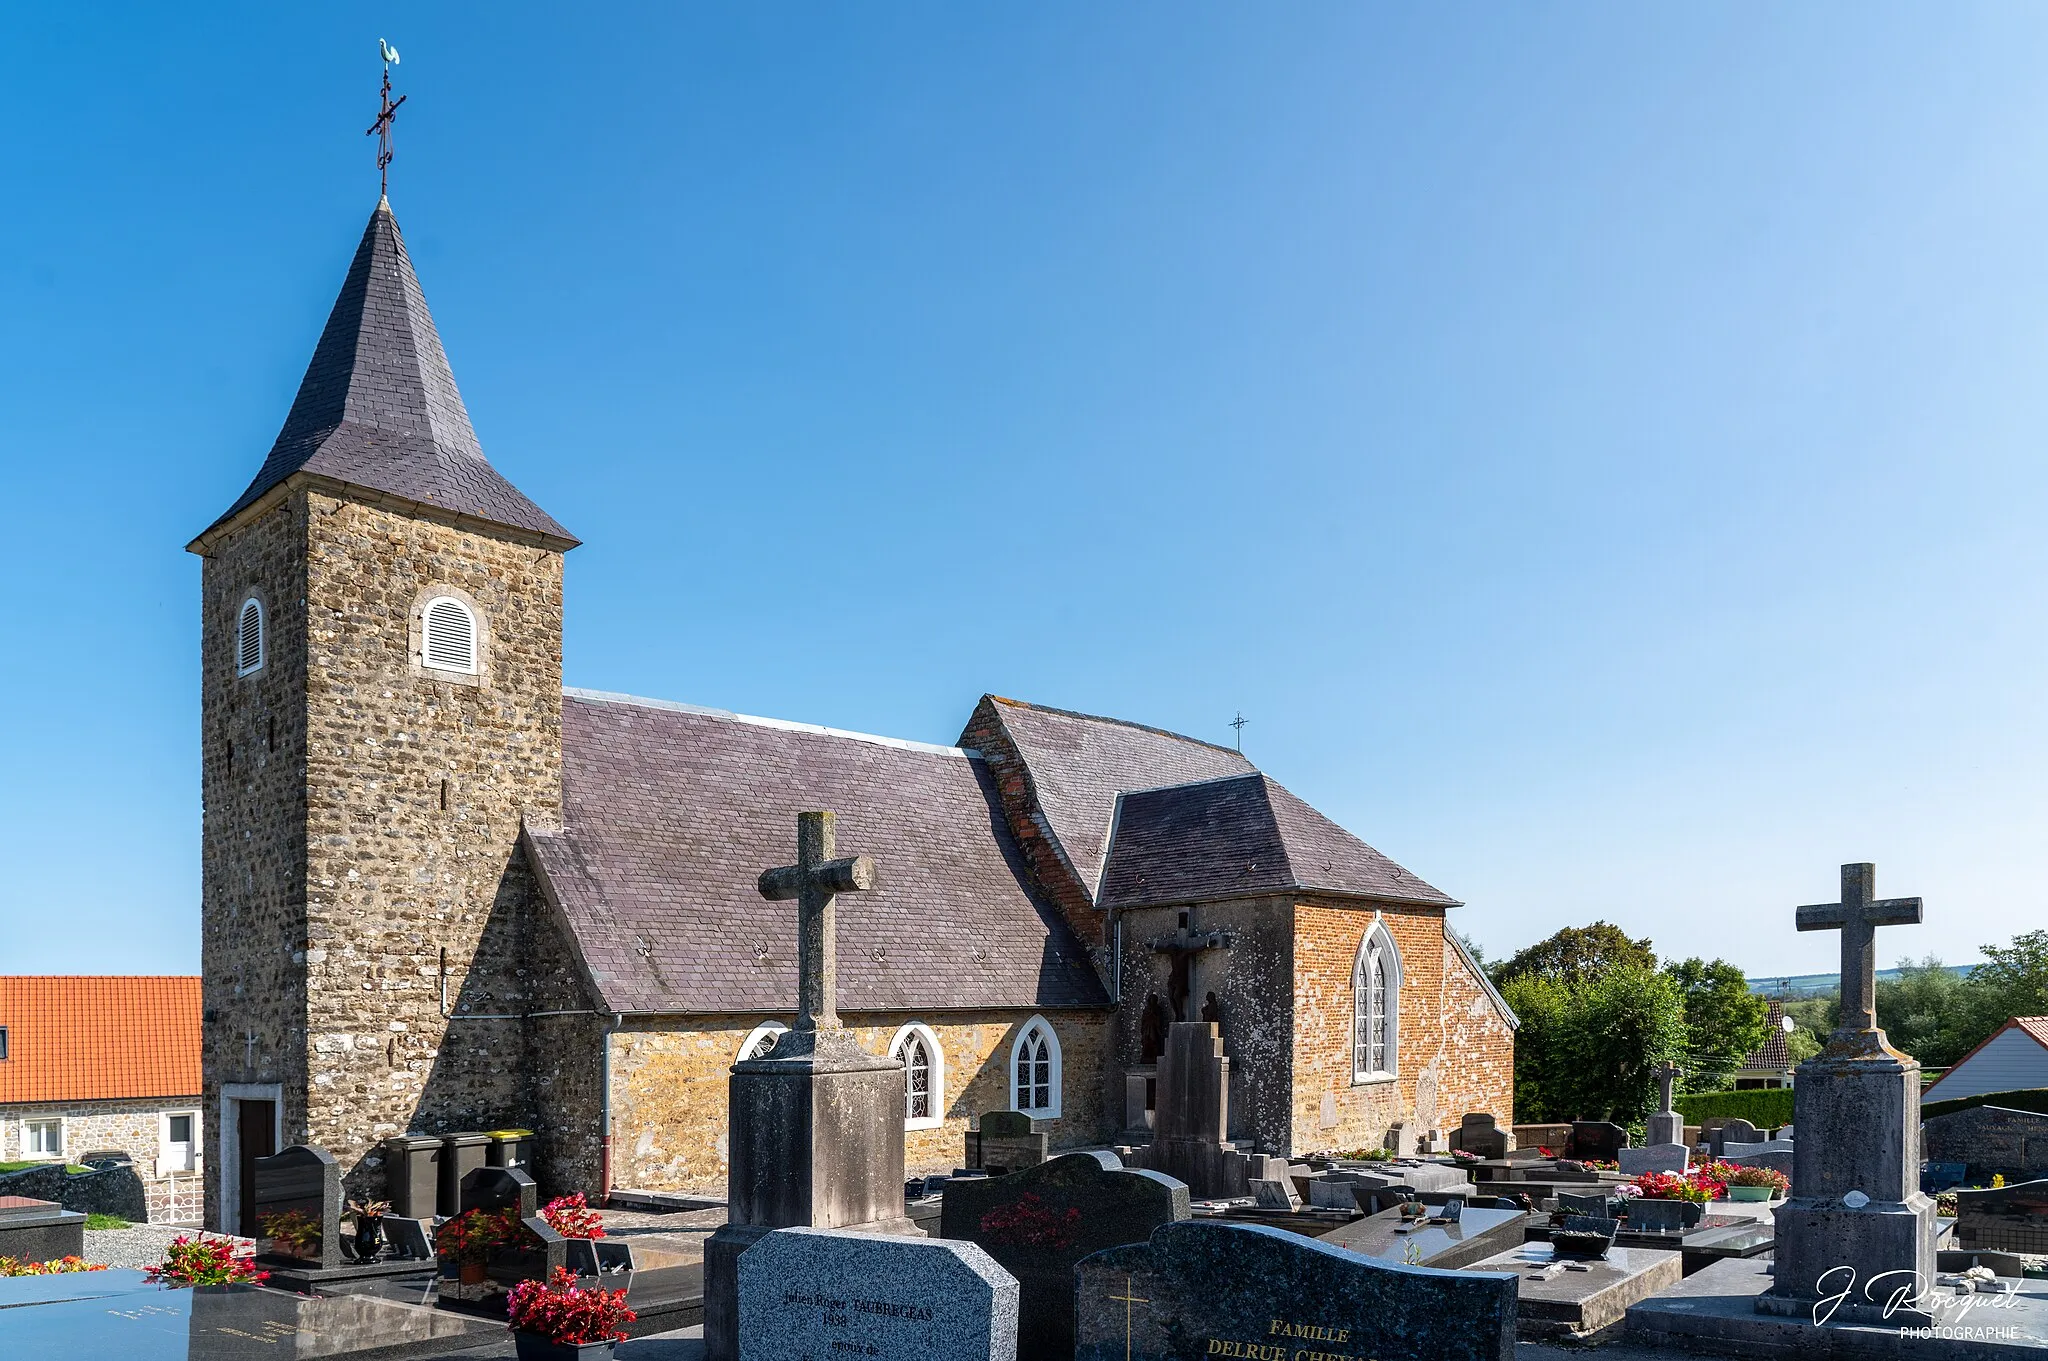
xmin=1073 ymin=1220 xmax=1516 ymax=1361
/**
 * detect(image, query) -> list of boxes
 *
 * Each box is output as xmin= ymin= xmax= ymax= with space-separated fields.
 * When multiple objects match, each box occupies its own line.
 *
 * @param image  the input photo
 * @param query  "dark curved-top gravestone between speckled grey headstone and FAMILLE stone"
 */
xmin=938 ymin=1152 xmax=1192 ymax=1357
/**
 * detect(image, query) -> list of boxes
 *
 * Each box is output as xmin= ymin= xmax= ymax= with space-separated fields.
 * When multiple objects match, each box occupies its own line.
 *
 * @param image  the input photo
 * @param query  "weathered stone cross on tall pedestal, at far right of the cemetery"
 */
xmin=1757 ymin=864 xmax=1935 ymax=1328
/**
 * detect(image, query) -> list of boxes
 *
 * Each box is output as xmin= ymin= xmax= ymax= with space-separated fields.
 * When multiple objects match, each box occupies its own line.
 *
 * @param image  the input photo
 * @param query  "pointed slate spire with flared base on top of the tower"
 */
xmin=193 ymin=201 xmax=575 ymax=551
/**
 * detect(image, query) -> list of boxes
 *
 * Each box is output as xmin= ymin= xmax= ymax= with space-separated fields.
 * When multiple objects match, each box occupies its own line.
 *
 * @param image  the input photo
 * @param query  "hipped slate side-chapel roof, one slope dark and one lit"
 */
xmin=1098 ymin=772 xmax=1456 ymax=907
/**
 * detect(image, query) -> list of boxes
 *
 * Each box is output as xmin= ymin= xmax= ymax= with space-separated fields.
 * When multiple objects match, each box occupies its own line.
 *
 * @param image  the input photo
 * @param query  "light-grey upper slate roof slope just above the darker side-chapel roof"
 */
xmin=966 ymin=696 xmax=1253 ymax=898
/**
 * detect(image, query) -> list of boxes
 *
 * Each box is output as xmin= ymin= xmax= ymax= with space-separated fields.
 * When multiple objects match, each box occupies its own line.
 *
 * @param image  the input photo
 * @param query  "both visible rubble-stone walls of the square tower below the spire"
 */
xmin=203 ymin=491 xmax=561 ymax=1219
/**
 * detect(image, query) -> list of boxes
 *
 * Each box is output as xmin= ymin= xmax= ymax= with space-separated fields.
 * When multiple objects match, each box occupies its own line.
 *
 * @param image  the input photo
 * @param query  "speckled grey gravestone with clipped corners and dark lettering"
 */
xmin=739 ymin=1228 xmax=1018 ymax=1361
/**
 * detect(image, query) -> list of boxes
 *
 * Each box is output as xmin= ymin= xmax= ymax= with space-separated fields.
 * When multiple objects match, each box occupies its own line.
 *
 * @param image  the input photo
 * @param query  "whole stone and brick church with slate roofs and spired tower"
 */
xmin=190 ymin=203 xmax=1516 ymax=1230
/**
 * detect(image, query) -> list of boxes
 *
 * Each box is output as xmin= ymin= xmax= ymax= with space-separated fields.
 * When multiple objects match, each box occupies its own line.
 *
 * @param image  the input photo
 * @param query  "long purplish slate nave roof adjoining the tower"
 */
xmin=526 ymin=690 xmax=1108 ymax=1013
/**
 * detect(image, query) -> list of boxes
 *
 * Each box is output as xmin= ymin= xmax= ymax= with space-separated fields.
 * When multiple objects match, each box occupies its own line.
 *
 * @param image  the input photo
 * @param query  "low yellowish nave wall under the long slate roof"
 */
xmin=612 ymin=1011 xmax=1112 ymax=1191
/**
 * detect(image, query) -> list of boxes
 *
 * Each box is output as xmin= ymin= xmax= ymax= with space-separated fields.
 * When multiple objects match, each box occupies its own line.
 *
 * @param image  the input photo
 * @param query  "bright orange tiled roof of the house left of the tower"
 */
xmin=0 ymin=974 xmax=201 ymax=1105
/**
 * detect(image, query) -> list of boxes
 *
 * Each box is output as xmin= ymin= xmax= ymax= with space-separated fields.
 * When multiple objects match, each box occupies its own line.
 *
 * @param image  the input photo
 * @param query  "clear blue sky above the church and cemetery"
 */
xmin=0 ymin=4 xmax=2048 ymax=974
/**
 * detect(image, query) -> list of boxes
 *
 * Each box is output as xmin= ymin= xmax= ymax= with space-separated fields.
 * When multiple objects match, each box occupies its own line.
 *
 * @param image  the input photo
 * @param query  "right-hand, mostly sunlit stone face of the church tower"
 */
xmin=299 ymin=495 xmax=561 ymax=1191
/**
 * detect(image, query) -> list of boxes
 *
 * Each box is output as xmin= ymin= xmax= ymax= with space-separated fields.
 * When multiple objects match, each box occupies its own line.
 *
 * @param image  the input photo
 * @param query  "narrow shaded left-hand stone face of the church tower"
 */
xmin=199 ymin=495 xmax=307 ymax=1216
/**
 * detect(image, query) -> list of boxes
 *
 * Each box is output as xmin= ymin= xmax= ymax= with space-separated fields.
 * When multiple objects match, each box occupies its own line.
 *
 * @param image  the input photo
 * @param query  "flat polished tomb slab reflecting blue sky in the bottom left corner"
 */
xmin=0 ymin=1271 xmax=504 ymax=1361
